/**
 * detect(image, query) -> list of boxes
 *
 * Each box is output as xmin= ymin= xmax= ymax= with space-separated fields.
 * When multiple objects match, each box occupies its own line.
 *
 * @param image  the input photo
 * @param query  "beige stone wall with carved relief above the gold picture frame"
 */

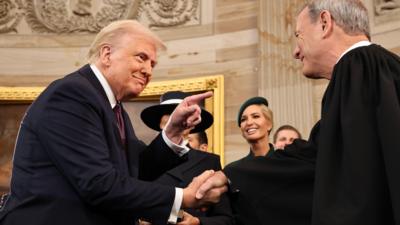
xmin=0 ymin=0 xmax=258 ymax=167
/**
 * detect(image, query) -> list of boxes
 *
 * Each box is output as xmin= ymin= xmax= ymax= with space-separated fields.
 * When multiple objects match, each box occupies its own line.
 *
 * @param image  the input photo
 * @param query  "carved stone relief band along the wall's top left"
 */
xmin=0 ymin=0 xmax=200 ymax=34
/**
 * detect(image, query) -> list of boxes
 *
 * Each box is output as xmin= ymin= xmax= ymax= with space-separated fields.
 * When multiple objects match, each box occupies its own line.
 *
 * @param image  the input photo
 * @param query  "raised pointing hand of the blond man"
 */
xmin=164 ymin=91 xmax=213 ymax=144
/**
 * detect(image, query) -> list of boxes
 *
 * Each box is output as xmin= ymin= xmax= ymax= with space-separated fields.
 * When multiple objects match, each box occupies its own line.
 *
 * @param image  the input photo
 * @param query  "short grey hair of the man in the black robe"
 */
xmin=306 ymin=0 xmax=371 ymax=39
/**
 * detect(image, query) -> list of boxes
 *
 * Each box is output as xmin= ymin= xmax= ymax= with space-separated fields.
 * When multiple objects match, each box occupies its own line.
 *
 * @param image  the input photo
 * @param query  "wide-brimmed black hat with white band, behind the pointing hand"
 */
xmin=140 ymin=91 xmax=214 ymax=133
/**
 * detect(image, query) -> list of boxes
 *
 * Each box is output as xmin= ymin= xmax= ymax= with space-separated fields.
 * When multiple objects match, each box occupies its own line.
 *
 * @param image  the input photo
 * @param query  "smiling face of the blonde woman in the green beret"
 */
xmin=240 ymin=105 xmax=272 ymax=143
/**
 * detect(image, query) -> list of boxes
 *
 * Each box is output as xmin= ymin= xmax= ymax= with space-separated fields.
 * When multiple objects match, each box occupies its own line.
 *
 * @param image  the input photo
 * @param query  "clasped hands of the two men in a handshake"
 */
xmin=182 ymin=170 xmax=228 ymax=208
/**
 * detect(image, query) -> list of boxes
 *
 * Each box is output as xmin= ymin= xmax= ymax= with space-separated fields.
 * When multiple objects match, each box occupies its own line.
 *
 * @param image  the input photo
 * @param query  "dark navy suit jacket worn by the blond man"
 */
xmin=0 ymin=65 xmax=182 ymax=225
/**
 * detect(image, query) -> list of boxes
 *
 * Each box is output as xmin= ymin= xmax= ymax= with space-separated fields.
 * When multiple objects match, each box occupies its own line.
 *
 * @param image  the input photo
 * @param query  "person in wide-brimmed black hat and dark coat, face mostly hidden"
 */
xmin=140 ymin=91 xmax=233 ymax=225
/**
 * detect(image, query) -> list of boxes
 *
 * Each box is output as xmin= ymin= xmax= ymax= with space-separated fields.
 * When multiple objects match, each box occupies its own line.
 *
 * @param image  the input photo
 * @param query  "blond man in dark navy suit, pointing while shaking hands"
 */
xmin=0 ymin=20 xmax=226 ymax=225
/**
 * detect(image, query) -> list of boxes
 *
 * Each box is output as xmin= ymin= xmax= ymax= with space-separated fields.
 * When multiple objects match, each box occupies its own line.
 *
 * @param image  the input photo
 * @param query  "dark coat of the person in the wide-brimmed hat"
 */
xmin=156 ymin=149 xmax=233 ymax=225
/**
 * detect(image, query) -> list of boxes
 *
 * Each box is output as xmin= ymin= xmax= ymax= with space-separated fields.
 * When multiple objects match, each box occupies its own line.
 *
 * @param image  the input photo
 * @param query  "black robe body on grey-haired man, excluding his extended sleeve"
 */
xmin=312 ymin=44 xmax=400 ymax=225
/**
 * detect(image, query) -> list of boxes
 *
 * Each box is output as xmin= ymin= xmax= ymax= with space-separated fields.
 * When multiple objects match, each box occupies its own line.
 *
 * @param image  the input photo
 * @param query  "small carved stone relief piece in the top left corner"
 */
xmin=0 ymin=0 xmax=24 ymax=33
